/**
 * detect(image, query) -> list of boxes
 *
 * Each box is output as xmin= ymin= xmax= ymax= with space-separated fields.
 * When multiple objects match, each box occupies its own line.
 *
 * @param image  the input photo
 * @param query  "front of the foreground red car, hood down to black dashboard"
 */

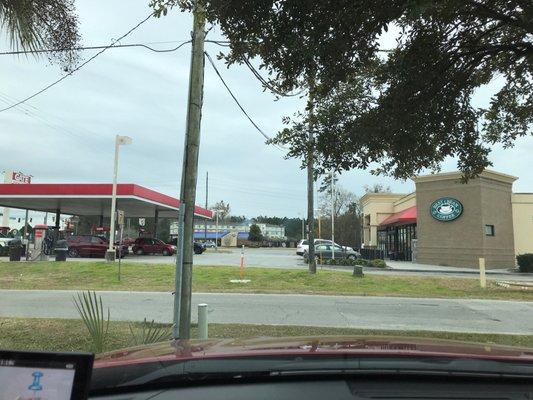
xmin=89 ymin=336 xmax=533 ymax=400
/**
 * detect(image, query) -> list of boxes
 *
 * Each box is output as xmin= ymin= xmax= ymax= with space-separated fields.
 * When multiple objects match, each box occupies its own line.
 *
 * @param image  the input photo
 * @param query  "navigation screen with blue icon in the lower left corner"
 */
xmin=0 ymin=359 xmax=76 ymax=400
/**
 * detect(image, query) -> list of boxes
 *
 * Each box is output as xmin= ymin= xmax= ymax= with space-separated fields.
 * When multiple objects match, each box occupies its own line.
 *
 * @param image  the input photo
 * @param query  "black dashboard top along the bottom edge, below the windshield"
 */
xmin=91 ymin=376 xmax=533 ymax=400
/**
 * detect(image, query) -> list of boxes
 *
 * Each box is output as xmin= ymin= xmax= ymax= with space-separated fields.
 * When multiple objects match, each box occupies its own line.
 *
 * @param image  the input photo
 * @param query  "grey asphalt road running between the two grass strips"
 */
xmin=0 ymin=290 xmax=533 ymax=334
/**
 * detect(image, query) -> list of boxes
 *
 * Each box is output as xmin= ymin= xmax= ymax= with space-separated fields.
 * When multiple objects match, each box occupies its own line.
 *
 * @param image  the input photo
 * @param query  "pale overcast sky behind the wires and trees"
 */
xmin=0 ymin=0 xmax=533 ymax=217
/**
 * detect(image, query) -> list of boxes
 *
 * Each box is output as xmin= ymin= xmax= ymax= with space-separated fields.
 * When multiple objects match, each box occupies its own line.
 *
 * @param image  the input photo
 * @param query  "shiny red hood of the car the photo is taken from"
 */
xmin=94 ymin=336 xmax=533 ymax=368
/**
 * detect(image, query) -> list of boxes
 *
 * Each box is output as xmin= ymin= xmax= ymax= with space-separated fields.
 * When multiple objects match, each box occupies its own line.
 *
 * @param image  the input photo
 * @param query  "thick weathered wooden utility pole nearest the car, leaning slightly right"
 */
xmin=175 ymin=0 xmax=205 ymax=339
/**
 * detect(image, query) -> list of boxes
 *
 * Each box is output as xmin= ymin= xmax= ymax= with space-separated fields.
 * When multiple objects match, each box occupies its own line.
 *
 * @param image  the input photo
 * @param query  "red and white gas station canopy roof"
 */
xmin=0 ymin=183 xmax=212 ymax=218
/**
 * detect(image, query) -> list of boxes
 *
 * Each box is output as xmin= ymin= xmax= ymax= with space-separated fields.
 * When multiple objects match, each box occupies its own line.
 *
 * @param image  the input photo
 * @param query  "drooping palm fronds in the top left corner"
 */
xmin=0 ymin=0 xmax=80 ymax=71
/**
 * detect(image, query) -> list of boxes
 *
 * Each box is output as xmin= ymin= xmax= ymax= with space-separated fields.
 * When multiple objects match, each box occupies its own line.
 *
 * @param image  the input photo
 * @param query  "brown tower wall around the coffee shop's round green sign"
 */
xmin=416 ymin=176 xmax=515 ymax=268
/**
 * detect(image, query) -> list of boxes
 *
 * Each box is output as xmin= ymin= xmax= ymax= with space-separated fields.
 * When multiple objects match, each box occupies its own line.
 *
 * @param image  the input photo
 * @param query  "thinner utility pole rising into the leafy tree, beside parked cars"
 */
xmin=307 ymin=76 xmax=316 ymax=274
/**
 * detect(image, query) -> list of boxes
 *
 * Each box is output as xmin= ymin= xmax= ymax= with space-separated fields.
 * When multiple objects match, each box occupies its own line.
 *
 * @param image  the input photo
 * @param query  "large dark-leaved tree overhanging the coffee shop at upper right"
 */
xmin=152 ymin=0 xmax=533 ymax=178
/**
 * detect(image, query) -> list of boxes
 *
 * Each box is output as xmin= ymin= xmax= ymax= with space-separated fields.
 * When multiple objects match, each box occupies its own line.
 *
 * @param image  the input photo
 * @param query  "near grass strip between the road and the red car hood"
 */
xmin=0 ymin=318 xmax=533 ymax=351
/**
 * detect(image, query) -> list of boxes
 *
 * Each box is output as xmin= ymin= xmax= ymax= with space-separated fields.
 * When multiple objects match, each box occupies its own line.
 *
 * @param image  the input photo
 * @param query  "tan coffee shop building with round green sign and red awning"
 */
xmin=362 ymin=170 xmax=533 ymax=268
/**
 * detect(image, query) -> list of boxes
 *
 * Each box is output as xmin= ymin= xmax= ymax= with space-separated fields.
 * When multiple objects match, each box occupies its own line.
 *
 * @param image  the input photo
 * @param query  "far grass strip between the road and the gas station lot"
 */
xmin=0 ymin=262 xmax=533 ymax=301
